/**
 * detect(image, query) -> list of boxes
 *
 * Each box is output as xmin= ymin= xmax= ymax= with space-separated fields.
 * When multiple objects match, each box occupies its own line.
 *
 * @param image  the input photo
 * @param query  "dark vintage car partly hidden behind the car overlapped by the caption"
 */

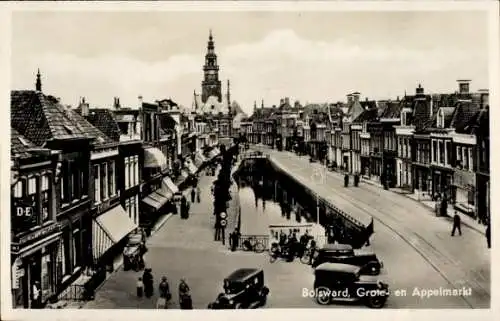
xmin=312 ymin=244 xmax=383 ymax=275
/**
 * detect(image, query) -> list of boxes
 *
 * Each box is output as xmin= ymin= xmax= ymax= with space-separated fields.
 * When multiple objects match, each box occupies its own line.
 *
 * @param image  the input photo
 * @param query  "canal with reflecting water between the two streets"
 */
xmin=234 ymin=158 xmax=373 ymax=248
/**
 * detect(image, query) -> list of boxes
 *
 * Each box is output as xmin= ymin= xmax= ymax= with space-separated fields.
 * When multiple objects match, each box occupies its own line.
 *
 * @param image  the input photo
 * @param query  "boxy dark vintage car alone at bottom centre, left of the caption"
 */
xmin=208 ymin=268 xmax=269 ymax=310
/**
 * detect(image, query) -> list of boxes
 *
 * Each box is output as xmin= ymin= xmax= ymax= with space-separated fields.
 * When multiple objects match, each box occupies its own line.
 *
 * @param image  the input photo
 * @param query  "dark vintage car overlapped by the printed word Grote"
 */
xmin=314 ymin=263 xmax=389 ymax=309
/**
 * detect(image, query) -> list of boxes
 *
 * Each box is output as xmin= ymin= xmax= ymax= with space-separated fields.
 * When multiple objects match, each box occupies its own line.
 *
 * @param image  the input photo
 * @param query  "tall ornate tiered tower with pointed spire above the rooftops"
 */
xmin=201 ymin=30 xmax=222 ymax=103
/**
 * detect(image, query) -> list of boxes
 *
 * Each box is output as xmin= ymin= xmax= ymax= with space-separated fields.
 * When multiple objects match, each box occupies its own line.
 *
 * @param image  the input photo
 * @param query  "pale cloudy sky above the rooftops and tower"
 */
xmin=11 ymin=11 xmax=489 ymax=113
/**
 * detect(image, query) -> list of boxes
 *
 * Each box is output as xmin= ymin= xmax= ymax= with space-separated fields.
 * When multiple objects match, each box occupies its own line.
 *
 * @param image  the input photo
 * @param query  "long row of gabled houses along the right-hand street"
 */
xmin=240 ymin=80 xmax=490 ymax=223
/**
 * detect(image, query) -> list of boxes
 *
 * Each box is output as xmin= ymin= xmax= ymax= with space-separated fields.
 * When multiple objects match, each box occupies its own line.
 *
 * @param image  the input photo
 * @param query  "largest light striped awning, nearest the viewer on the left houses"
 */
xmin=92 ymin=205 xmax=137 ymax=259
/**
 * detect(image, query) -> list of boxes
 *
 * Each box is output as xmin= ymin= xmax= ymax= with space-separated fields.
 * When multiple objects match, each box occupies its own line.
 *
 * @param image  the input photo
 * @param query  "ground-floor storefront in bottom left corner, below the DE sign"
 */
xmin=11 ymin=223 xmax=62 ymax=308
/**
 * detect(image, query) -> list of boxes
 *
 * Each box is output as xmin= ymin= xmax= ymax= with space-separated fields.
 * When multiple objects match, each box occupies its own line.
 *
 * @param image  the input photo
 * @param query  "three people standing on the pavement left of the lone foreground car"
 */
xmin=137 ymin=268 xmax=193 ymax=310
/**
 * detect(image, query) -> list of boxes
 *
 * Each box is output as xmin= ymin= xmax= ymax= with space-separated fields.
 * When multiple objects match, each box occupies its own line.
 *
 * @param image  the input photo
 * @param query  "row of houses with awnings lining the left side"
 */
xmin=11 ymin=72 xmax=231 ymax=308
